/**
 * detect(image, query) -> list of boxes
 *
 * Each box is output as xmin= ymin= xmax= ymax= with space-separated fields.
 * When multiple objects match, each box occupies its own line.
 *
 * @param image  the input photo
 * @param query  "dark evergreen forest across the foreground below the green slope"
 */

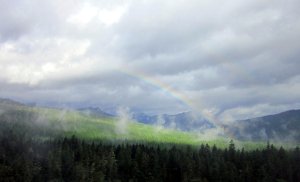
xmin=0 ymin=131 xmax=300 ymax=182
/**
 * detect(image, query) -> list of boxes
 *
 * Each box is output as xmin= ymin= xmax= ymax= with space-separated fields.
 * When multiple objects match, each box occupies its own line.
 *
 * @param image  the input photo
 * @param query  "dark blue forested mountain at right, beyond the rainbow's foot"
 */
xmin=225 ymin=110 xmax=300 ymax=142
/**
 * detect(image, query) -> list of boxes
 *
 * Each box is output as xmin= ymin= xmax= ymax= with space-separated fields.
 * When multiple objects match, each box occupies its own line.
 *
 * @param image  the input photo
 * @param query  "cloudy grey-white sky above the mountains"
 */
xmin=0 ymin=0 xmax=300 ymax=121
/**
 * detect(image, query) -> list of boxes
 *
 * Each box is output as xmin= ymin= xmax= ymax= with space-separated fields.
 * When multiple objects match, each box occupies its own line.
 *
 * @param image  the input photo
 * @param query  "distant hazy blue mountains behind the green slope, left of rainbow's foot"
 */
xmin=133 ymin=112 xmax=215 ymax=131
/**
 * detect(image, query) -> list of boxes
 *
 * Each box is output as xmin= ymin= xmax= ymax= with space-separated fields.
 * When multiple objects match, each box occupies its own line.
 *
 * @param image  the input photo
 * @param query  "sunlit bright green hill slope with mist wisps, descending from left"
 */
xmin=0 ymin=100 xmax=206 ymax=144
